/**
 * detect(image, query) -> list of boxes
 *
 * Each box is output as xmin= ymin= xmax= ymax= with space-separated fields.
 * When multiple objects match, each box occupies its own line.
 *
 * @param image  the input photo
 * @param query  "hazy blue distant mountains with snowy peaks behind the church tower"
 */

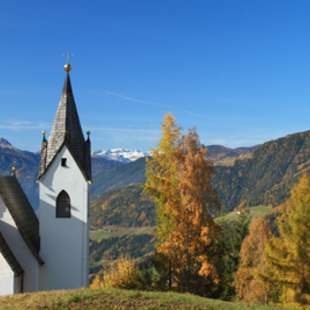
xmin=0 ymin=138 xmax=252 ymax=208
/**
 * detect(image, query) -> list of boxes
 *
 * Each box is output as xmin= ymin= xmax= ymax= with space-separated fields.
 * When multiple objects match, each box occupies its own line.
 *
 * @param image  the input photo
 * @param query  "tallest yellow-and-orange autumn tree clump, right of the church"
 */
xmin=145 ymin=115 xmax=220 ymax=295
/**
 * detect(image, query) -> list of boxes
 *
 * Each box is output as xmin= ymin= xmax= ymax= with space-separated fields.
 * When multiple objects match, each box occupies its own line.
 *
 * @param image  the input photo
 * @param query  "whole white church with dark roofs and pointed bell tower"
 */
xmin=0 ymin=64 xmax=91 ymax=295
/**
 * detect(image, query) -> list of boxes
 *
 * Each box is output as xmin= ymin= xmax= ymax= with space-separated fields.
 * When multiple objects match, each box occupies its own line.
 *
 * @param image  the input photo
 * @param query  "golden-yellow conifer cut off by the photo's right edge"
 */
xmin=261 ymin=174 xmax=310 ymax=304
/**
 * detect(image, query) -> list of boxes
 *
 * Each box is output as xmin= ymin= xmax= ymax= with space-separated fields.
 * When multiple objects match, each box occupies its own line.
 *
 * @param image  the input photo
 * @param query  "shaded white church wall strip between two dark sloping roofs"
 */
xmin=0 ymin=197 xmax=39 ymax=292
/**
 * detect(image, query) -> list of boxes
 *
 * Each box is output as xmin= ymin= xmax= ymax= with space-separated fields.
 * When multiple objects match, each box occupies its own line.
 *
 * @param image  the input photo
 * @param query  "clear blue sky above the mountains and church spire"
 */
xmin=0 ymin=0 xmax=310 ymax=150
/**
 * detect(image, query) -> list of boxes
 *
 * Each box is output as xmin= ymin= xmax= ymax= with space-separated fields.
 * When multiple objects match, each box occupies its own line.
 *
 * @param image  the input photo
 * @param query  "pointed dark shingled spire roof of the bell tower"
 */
xmin=39 ymin=73 xmax=91 ymax=181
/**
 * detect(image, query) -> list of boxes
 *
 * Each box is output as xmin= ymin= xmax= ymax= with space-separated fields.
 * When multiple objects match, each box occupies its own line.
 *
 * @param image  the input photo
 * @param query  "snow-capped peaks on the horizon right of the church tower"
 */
xmin=93 ymin=148 xmax=147 ymax=163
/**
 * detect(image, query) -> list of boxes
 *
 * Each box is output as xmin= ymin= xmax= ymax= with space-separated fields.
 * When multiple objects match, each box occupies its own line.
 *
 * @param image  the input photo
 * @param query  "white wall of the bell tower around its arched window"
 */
xmin=37 ymin=146 xmax=89 ymax=290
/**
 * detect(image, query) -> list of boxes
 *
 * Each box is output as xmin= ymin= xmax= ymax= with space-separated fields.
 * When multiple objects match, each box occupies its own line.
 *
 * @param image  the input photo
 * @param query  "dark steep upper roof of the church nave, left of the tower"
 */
xmin=0 ymin=176 xmax=44 ymax=264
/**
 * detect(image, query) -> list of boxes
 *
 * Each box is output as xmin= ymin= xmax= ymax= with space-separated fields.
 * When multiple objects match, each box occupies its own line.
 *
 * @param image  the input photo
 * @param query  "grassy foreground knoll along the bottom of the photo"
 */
xmin=0 ymin=289 xmax=284 ymax=310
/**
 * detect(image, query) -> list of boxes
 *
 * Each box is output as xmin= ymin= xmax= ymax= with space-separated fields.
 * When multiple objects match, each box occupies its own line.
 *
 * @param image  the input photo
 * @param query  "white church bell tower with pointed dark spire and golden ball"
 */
xmin=38 ymin=64 xmax=91 ymax=290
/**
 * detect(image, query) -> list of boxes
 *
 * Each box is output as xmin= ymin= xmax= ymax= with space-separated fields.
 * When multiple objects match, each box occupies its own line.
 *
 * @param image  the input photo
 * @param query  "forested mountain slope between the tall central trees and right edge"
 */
xmin=214 ymin=131 xmax=310 ymax=210
